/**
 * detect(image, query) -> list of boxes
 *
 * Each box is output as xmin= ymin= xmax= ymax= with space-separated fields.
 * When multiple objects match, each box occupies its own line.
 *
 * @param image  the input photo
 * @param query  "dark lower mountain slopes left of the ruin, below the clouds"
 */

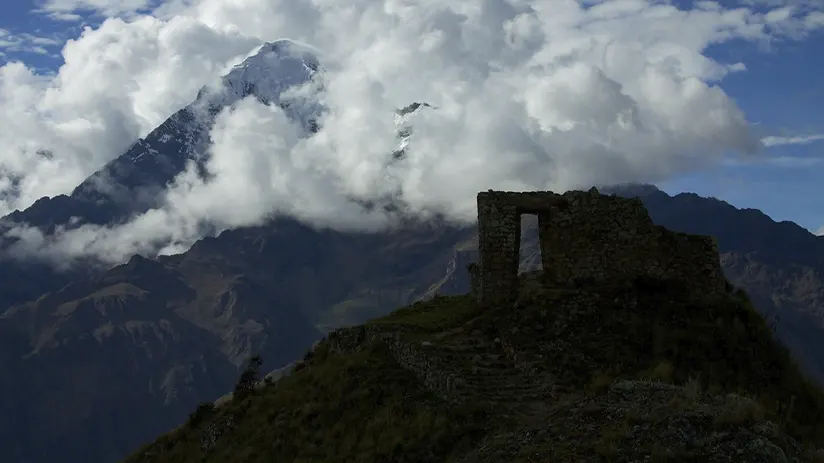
xmin=0 ymin=219 xmax=464 ymax=463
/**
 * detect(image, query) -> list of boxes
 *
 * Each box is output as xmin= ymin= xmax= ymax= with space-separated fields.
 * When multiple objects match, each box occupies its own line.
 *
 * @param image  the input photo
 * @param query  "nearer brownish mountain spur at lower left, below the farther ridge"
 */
xmin=0 ymin=257 xmax=320 ymax=463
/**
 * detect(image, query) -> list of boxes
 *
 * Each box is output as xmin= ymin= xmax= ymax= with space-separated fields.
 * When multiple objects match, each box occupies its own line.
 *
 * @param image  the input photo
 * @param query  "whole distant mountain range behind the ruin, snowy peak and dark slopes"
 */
xmin=0 ymin=41 xmax=824 ymax=463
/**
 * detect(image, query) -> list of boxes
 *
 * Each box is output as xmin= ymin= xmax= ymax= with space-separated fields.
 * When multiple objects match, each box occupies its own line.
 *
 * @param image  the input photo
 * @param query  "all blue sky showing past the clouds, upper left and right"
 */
xmin=0 ymin=0 xmax=824 ymax=231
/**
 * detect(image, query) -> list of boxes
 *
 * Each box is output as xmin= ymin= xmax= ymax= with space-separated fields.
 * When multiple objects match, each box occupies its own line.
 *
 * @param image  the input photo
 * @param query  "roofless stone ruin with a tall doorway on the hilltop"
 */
xmin=469 ymin=188 xmax=726 ymax=306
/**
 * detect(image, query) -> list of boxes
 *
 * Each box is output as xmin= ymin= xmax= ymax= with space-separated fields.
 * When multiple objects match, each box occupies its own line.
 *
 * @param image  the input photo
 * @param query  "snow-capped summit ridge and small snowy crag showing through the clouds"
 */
xmin=8 ymin=39 xmax=432 ymax=230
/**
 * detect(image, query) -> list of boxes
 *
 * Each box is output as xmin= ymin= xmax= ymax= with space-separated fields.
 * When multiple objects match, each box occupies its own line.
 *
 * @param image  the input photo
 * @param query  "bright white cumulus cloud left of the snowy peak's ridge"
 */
xmin=0 ymin=16 xmax=259 ymax=215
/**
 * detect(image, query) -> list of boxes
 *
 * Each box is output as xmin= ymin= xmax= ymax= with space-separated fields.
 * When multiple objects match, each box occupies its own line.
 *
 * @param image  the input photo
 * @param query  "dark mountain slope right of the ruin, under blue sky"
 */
xmin=612 ymin=187 xmax=824 ymax=383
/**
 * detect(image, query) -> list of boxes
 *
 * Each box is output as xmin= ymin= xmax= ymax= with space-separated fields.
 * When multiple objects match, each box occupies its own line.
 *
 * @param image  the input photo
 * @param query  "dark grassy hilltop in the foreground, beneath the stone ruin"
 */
xmin=126 ymin=274 xmax=824 ymax=463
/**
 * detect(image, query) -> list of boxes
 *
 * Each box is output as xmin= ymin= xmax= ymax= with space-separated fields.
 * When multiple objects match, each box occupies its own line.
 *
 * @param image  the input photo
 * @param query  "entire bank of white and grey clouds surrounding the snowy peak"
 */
xmin=0 ymin=0 xmax=824 ymax=263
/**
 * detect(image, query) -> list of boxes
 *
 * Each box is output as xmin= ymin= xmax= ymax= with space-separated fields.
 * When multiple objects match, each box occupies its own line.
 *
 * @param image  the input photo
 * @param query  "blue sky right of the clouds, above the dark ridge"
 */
xmin=662 ymin=20 xmax=824 ymax=231
